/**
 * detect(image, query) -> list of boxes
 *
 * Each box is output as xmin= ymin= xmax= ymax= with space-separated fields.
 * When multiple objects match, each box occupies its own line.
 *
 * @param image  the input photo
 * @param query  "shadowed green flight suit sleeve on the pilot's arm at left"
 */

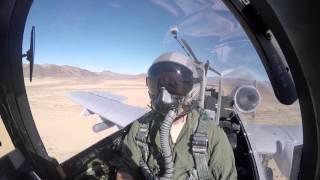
xmin=118 ymin=121 xmax=141 ymax=178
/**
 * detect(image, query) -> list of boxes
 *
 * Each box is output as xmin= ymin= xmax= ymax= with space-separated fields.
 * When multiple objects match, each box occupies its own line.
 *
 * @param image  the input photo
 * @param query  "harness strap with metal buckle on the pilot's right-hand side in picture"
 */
xmin=192 ymin=110 xmax=210 ymax=180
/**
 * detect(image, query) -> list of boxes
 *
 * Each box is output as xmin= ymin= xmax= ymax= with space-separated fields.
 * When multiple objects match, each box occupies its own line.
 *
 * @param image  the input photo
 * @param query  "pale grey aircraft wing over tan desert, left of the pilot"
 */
xmin=67 ymin=91 xmax=147 ymax=132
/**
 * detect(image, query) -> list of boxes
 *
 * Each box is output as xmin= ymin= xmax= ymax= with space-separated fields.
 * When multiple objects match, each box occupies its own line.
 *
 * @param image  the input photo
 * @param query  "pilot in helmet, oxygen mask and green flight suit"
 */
xmin=116 ymin=52 xmax=237 ymax=180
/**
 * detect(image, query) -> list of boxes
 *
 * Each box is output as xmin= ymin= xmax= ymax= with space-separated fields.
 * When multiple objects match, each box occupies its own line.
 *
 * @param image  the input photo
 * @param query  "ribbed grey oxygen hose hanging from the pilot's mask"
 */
xmin=159 ymin=110 xmax=178 ymax=180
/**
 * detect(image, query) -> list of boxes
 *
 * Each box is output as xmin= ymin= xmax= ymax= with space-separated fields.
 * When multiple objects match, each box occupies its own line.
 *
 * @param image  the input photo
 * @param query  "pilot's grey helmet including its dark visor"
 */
xmin=146 ymin=52 xmax=200 ymax=110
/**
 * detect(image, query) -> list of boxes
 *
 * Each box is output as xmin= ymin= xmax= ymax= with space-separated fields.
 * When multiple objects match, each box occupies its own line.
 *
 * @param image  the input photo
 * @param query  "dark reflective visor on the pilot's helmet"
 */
xmin=147 ymin=62 xmax=194 ymax=96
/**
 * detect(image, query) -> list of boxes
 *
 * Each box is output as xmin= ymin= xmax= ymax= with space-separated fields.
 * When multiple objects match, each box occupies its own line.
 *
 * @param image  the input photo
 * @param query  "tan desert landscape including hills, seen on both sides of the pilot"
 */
xmin=0 ymin=64 xmax=300 ymax=179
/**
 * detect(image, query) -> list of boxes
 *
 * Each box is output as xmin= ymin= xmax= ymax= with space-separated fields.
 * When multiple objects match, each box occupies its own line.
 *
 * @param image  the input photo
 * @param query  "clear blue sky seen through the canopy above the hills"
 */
xmin=24 ymin=0 xmax=265 ymax=79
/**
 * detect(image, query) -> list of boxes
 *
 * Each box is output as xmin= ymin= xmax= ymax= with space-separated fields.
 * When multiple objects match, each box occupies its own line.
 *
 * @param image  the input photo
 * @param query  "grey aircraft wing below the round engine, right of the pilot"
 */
xmin=243 ymin=123 xmax=303 ymax=177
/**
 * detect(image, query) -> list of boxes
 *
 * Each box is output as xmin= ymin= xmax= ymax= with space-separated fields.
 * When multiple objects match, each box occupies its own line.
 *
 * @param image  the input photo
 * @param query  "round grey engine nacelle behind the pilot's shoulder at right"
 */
xmin=234 ymin=85 xmax=261 ymax=113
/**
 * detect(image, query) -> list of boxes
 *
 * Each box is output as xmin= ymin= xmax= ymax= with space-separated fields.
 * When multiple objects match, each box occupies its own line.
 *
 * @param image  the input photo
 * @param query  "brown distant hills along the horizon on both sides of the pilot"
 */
xmin=23 ymin=64 xmax=274 ymax=99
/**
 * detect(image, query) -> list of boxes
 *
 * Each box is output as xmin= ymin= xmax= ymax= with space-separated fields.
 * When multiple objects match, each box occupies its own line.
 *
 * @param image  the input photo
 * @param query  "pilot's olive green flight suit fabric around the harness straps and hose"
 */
xmin=118 ymin=110 xmax=237 ymax=180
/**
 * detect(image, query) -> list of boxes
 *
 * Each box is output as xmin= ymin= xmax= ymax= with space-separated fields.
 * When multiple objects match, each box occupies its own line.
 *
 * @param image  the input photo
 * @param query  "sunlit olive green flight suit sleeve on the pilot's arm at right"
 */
xmin=209 ymin=125 xmax=237 ymax=180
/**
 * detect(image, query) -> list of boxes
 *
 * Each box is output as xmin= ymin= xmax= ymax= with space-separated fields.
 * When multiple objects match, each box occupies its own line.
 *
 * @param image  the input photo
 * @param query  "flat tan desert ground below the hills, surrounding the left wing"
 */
xmin=0 ymin=78 xmax=299 ymax=179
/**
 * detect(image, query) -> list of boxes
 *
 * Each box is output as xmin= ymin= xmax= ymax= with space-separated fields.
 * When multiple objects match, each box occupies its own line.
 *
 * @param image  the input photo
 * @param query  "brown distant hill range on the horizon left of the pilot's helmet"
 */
xmin=23 ymin=64 xmax=145 ymax=79
